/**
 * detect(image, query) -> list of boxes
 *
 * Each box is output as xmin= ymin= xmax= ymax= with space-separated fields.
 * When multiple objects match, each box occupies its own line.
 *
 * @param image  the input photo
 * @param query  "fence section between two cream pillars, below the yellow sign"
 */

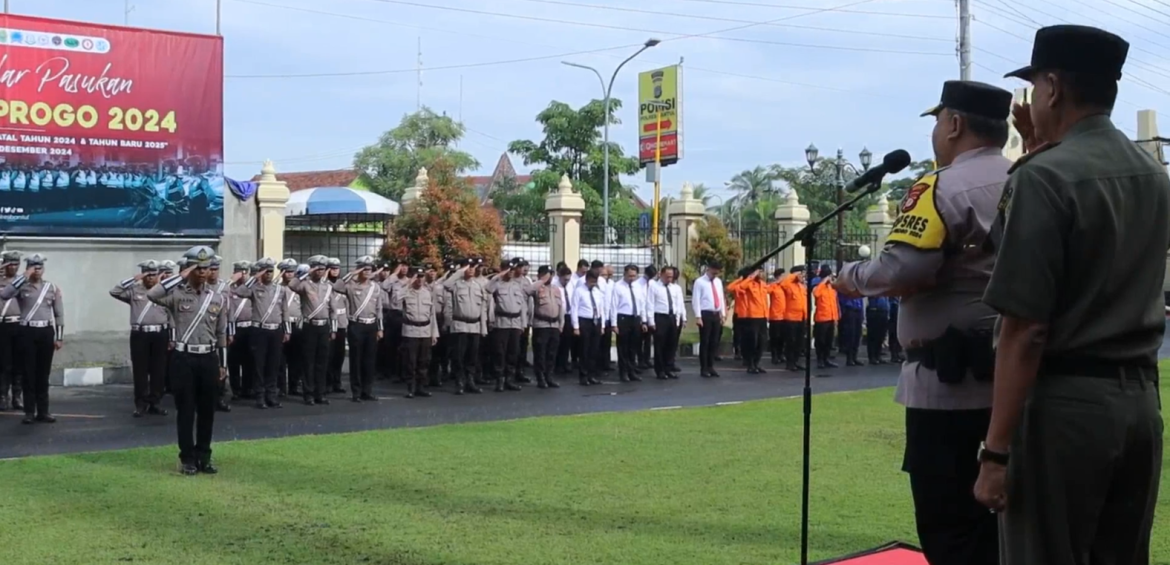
xmin=580 ymin=222 xmax=679 ymax=267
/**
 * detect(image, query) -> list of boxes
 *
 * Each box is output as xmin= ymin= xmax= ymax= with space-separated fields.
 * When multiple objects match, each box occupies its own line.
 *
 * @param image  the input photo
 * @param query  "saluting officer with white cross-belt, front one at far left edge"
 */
xmin=0 ymin=253 xmax=66 ymax=423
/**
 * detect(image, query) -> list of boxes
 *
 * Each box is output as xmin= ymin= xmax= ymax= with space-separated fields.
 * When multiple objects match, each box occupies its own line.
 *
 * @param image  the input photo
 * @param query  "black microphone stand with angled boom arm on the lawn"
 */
xmin=752 ymin=178 xmax=881 ymax=565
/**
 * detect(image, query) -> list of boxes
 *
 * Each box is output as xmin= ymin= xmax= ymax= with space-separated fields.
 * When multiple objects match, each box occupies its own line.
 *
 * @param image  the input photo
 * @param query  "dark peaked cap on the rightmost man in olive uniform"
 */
xmin=1004 ymin=26 xmax=1129 ymax=81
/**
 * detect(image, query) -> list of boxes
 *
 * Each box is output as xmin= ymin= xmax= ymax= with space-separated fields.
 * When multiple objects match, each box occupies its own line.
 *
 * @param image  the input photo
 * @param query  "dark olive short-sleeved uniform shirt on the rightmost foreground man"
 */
xmin=987 ymin=115 xmax=1170 ymax=366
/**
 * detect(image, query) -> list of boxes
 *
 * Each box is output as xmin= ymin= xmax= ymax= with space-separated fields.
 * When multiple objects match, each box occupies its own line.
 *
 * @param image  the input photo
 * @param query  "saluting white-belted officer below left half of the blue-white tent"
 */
xmin=289 ymin=255 xmax=337 ymax=406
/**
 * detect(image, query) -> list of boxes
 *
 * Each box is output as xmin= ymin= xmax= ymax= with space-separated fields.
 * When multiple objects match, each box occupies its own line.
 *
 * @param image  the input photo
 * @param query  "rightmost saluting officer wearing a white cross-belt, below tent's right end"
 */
xmin=333 ymin=255 xmax=385 ymax=402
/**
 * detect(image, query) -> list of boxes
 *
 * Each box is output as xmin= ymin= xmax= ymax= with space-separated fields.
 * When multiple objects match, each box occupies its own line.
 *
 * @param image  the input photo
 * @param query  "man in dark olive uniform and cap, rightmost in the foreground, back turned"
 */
xmin=978 ymin=26 xmax=1170 ymax=565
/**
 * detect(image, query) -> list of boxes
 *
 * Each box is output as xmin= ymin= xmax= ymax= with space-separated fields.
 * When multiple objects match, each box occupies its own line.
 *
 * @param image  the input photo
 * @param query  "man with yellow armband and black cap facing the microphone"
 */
xmin=834 ymin=81 xmax=1012 ymax=564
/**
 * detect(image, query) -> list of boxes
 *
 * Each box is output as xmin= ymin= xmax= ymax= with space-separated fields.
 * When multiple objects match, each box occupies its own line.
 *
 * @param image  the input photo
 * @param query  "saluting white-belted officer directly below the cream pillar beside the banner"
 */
xmin=232 ymin=257 xmax=293 ymax=409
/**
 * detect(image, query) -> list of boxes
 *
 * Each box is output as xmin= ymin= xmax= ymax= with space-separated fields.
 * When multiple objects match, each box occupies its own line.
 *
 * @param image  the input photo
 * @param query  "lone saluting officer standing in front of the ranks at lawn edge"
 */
xmin=146 ymin=246 xmax=228 ymax=475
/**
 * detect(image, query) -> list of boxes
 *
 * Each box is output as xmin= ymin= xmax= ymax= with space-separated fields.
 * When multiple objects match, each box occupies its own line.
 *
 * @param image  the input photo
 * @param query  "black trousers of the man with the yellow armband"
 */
xmin=902 ymin=408 xmax=996 ymax=565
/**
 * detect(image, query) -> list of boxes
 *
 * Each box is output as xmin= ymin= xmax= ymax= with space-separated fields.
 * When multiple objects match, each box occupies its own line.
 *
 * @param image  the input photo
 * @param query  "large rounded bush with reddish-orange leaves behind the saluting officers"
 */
xmin=381 ymin=159 xmax=503 ymax=264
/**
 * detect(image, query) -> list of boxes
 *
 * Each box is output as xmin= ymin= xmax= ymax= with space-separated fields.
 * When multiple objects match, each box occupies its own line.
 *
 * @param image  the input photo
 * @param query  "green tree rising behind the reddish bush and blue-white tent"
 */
xmin=353 ymin=108 xmax=480 ymax=200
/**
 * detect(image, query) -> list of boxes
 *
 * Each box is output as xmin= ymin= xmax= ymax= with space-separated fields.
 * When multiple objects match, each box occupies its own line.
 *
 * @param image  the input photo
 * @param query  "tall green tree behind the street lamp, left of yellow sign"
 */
xmin=507 ymin=98 xmax=640 ymax=232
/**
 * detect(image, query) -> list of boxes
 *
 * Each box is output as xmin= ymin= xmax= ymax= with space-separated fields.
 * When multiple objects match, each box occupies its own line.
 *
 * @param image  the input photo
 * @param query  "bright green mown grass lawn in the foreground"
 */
xmin=0 ymin=364 xmax=1170 ymax=565
